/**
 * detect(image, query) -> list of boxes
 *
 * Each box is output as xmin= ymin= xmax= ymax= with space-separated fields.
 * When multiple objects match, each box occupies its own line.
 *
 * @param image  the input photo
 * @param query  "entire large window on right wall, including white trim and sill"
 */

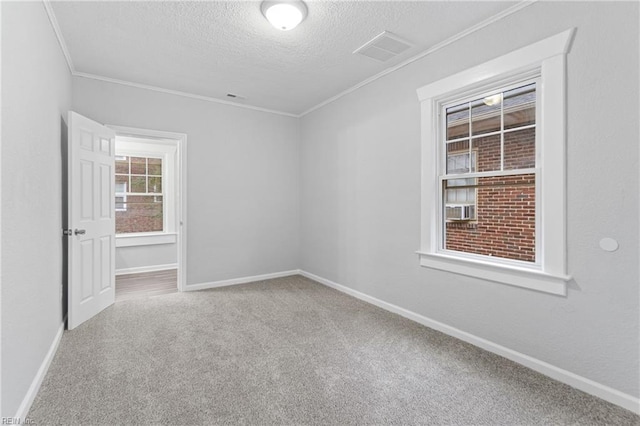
xmin=418 ymin=30 xmax=573 ymax=295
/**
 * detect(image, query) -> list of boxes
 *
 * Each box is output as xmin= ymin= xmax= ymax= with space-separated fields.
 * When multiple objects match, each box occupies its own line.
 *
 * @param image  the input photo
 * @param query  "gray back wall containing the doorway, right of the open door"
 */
xmin=73 ymin=77 xmax=300 ymax=284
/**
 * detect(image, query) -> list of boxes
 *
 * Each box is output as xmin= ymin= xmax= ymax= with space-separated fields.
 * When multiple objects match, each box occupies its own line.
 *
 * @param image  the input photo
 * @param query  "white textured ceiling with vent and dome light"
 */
xmin=51 ymin=1 xmax=516 ymax=114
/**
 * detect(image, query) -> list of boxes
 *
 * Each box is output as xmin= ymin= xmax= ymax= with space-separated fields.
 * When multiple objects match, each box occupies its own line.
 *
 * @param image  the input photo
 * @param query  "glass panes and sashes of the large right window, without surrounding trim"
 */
xmin=438 ymin=82 xmax=539 ymax=262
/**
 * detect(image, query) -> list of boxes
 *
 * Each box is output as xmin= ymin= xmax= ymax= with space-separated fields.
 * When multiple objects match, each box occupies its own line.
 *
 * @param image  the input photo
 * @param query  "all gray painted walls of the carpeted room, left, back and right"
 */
xmin=1 ymin=3 xmax=640 ymax=416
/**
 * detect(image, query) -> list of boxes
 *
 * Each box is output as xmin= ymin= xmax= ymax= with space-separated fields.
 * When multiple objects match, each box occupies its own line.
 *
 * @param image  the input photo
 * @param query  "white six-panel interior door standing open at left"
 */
xmin=68 ymin=111 xmax=116 ymax=330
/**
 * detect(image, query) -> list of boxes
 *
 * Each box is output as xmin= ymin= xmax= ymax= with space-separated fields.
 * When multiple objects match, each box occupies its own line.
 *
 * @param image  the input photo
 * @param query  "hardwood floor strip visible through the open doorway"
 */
xmin=116 ymin=269 xmax=178 ymax=302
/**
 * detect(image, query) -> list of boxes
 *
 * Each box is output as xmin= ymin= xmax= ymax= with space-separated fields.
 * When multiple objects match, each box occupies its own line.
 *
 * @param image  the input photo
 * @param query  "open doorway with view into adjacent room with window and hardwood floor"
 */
xmin=108 ymin=126 xmax=186 ymax=302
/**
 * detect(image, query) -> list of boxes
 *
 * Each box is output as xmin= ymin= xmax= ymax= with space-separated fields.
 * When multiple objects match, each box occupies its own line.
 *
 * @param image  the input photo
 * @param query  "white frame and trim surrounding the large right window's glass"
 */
xmin=417 ymin=28 xmax=575 ymax=296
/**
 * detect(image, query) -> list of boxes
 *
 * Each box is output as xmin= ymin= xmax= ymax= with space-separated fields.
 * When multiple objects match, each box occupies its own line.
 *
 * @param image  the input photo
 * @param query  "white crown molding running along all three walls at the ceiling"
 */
xmin=42 ymin=0 xmax=539 ymax=118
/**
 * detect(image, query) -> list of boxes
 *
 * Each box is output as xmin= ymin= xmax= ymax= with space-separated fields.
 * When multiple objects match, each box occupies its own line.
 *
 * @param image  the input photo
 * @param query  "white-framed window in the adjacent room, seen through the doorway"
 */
xmin=114 ymin=136 xmax=177 ymax=247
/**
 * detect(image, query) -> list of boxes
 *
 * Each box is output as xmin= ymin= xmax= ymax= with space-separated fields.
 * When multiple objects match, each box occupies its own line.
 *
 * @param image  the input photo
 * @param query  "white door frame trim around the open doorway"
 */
xmin=106 ymin=124 xmax=187 ymax=292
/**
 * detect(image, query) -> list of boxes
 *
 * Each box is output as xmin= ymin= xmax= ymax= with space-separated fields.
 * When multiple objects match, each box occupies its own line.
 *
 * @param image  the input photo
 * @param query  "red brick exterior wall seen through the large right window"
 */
xmin=445 ymin=128 xmax=536 ymax=262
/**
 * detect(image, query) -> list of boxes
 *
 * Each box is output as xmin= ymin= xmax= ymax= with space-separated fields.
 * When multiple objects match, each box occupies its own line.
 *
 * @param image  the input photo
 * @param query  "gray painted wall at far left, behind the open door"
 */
xmin=1 ymin=2 xmax=71 ymax=417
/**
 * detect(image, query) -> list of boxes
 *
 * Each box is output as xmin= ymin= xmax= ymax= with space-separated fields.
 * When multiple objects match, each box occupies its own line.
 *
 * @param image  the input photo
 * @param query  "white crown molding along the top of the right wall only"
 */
xmin=298 ymin=0 xmax=538 ymax=117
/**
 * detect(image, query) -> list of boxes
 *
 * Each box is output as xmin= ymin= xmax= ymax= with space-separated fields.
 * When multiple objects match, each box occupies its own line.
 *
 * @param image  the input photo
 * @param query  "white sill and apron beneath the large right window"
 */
xmin=416 ymin=251 xmax=571 ymax=296
